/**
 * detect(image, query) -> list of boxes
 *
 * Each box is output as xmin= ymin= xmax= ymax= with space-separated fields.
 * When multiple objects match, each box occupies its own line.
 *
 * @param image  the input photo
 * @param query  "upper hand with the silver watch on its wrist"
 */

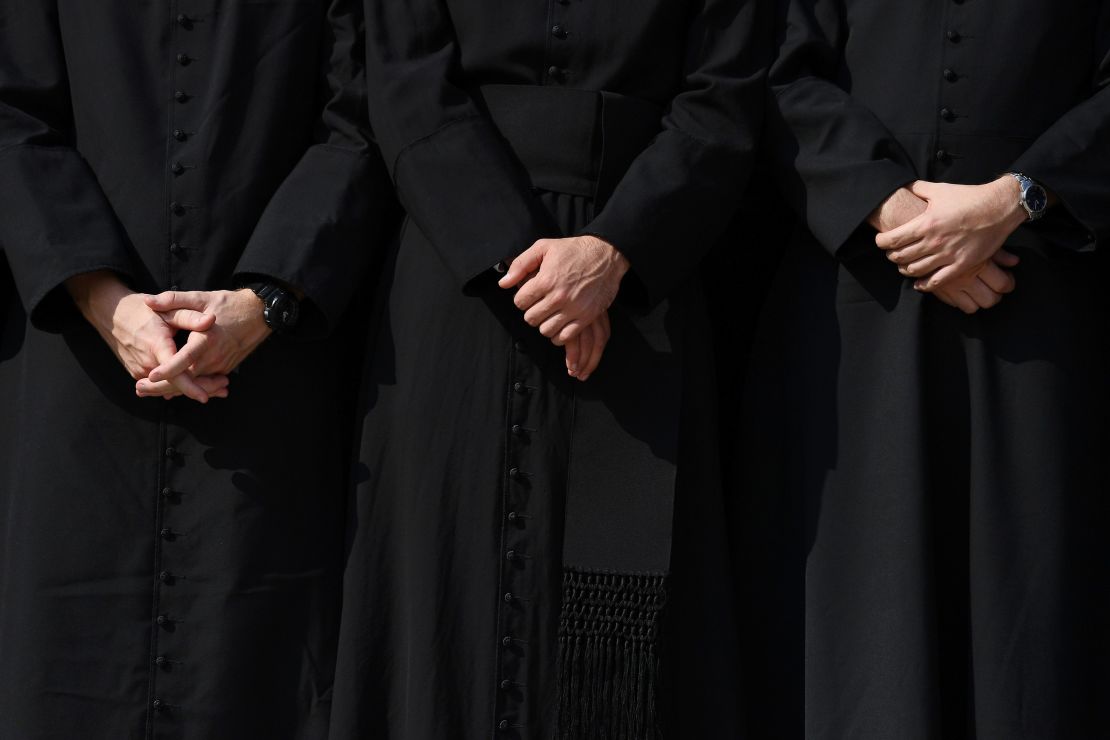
xmin=875 ymin=175 xmax=1028 ymax=292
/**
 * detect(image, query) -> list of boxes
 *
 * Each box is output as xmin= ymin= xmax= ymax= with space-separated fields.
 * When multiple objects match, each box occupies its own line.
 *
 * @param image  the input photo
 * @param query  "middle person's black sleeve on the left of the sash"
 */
xmin=365 ymin=0 xmax=558 ymax=291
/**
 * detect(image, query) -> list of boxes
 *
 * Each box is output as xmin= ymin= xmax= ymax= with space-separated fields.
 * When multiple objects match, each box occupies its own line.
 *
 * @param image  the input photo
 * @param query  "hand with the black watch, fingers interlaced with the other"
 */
xmin=135 ymin=288 xmax=272 ymax=395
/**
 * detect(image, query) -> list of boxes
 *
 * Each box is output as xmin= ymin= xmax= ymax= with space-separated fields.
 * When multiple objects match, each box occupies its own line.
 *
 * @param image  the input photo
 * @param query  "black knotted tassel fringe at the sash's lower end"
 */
xmin=556 ymin=568 xmax=667 ymax=740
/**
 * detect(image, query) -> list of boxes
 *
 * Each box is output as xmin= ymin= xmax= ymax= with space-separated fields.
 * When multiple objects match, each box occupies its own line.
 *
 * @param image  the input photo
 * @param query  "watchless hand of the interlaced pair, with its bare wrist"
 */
xmin=65 ymin=271 xmax=228 ymax=404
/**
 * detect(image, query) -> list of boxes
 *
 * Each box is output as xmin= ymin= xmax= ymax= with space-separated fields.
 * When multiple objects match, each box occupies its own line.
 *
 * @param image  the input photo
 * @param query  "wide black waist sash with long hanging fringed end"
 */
xmin=481 ymin=85 xmax=682 ymax=740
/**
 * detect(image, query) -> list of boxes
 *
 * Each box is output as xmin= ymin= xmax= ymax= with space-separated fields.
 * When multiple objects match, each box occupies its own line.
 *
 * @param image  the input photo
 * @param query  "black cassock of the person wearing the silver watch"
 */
xmin=738 ymin=0 xmax=1110 ymax=740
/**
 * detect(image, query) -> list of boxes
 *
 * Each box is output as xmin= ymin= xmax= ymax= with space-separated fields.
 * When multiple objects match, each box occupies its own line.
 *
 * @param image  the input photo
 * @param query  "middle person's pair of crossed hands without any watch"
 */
xmin=498 ymin=236 xmax=629 ymax=381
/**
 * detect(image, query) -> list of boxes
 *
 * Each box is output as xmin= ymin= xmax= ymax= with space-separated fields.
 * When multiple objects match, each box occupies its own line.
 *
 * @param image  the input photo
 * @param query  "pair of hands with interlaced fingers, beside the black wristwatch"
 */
xmin=67 ymin=273 xmax=270 ymax=404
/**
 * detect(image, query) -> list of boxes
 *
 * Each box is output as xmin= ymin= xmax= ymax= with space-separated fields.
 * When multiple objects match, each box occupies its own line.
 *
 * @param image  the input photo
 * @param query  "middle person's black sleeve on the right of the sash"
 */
xmin=584 ymin=0 xmax=766 ymax=303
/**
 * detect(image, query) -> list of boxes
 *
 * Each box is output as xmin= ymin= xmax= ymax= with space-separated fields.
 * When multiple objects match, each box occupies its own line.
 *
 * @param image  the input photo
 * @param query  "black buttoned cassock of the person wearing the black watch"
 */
xmin=0 ymin=0 xmax=390 ymax=740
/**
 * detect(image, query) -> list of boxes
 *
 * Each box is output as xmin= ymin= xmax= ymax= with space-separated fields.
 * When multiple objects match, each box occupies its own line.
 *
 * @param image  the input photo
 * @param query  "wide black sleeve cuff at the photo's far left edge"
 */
xmin=0 ymin=144 xmax=137 ymax=327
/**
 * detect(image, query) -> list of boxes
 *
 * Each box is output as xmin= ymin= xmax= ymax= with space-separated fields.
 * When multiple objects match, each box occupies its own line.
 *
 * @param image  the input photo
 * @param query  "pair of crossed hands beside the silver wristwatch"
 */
xmin=871 ymin=175 xmax=1027 ymax=314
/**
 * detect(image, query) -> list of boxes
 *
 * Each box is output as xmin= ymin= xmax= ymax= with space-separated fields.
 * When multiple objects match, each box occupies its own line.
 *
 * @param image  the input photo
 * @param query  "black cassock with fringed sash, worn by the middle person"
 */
xmin=332 ymin=0 xmax=763 ymax=740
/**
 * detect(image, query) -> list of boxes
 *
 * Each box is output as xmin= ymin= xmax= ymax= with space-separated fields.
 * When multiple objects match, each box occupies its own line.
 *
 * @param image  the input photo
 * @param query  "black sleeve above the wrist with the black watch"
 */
xmin=235 ymin=0 xmax=397 ymax=335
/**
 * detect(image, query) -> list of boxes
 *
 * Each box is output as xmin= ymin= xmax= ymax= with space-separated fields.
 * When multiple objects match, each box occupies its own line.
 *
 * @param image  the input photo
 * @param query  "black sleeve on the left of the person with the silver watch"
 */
xmin=767 ymin=0 xmax=918 ymax=253
